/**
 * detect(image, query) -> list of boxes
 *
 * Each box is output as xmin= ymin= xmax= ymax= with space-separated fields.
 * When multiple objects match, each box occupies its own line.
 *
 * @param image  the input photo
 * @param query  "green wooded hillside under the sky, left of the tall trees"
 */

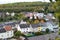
xmin=0 ymin=2 xmax=49 ymax=12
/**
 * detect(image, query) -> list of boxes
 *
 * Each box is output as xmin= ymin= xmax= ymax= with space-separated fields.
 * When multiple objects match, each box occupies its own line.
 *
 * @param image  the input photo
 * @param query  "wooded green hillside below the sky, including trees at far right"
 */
xmin=0 ymin=0 xmax=60 ymax=12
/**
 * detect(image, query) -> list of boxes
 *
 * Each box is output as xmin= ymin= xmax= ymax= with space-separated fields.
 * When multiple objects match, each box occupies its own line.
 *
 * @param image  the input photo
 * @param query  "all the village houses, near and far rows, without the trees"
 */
xmin=0 ymin=13 xmax=58 ymax=39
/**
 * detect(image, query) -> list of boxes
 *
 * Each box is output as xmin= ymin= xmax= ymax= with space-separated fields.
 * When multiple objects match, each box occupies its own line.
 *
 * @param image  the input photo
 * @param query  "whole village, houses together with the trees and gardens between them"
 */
xmin=0 ymin=12 xmax=59 ymax=40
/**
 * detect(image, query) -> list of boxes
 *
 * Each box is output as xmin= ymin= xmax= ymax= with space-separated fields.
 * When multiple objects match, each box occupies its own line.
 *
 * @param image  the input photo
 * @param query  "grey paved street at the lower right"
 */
xmin=28 ymin=33 xmax=59 ymax=40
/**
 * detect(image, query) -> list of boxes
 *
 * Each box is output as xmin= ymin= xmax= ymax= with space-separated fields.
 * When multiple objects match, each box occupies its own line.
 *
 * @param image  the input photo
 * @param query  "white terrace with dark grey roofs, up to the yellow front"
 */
xmin=17 ymin=24 xmax=41 ymax=33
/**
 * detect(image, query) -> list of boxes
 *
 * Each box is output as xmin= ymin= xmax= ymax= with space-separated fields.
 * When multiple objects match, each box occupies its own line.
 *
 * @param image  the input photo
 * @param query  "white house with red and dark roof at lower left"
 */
xmin=0 ymin=26 xmax=14 ymax=39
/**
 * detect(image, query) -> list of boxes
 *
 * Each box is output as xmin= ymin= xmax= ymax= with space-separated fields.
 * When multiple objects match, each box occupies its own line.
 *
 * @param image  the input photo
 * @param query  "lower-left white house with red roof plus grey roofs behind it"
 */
xmin=0 ymin=22 xmax=15 ymax=40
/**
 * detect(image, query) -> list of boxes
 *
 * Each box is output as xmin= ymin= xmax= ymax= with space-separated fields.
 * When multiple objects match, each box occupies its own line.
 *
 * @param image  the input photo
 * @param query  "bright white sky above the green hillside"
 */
xmin=0 ymin=0 xmax=54 ymax=4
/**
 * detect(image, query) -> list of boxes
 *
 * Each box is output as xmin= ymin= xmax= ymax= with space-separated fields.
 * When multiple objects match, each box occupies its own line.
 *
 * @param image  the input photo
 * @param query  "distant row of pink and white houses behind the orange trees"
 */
xmin=25 ymin=12 xmax=55 ymax=20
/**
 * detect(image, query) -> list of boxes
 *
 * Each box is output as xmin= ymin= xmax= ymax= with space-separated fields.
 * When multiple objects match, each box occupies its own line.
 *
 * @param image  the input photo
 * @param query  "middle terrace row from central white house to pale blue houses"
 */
xmin=16 ymin=21 xmax=58 ymax=33
